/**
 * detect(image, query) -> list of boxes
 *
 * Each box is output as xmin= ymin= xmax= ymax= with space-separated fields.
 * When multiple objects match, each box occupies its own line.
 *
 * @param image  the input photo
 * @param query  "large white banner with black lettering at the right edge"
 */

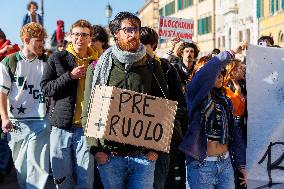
xmin=246 ymin=46 xmax=284 ymax=189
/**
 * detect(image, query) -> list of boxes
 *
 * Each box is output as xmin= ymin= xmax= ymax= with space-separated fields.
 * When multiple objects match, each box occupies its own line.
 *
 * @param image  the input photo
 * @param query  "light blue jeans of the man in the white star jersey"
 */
xmin=8 ymin=120 xmax=50 ymax=189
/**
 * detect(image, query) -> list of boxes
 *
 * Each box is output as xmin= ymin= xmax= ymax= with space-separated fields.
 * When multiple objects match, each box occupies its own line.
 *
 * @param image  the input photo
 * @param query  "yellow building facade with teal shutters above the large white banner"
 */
xmin=257 ymin=0 xmax=284 ymax=47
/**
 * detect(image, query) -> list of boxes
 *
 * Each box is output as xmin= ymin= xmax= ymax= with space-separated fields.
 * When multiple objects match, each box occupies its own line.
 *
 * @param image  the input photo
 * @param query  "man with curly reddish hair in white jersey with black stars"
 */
xmin=0 ymin=23 xmax=50 ymax=188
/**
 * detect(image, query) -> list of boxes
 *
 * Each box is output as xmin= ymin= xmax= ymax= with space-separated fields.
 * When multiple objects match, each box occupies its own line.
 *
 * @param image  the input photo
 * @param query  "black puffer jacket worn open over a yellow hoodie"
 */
xmin=40 ymin=51 xmax=92 ymax=129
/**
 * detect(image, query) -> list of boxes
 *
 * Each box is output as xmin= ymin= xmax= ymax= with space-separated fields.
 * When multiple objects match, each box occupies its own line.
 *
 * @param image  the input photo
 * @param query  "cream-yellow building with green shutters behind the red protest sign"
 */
xmin=159 ymin=0 xmax=215 ymax=56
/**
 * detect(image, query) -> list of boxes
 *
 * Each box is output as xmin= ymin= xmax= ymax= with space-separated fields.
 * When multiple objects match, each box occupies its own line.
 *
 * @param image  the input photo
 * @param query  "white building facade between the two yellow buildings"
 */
xmin=215 ymin=0 xmax=258 ymax=50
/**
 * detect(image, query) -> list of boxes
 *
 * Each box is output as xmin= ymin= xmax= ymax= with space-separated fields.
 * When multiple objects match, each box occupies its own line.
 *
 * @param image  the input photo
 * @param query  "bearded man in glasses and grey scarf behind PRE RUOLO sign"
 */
xmin=82 ymin=12 xmax=168 ymax=189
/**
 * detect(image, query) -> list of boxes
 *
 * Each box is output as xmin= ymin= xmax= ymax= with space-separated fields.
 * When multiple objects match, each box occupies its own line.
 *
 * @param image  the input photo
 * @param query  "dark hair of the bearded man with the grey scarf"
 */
xmin=109 ymin=12 xmax=141 ymax=36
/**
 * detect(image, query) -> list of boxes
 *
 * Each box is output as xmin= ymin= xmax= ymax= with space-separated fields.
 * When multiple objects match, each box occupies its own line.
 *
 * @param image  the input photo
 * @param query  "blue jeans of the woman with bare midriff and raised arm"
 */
xmin=187 ymin=157 xmax=235 ymax=189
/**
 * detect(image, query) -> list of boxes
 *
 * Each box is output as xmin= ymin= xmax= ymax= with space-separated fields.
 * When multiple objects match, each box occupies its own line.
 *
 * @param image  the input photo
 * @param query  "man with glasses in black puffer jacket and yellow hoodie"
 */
xmin=41 ymin=20 xmax=98 ymax=188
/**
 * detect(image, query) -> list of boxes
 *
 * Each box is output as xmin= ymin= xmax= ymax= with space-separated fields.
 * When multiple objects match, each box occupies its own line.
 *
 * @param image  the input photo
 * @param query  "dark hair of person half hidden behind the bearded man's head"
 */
xmin=140 ymin=27 xmax=159 ymax=51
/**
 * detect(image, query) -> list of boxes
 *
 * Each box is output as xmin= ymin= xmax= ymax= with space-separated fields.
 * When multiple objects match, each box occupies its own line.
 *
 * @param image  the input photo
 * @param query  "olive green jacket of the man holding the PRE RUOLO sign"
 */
xmin=81 ymin=55 xmax=168 ymax=154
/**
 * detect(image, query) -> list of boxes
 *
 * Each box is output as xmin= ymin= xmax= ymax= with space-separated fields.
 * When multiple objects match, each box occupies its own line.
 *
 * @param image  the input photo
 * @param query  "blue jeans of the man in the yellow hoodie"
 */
xmin=50 ymin=127 xmax=94 ymax=189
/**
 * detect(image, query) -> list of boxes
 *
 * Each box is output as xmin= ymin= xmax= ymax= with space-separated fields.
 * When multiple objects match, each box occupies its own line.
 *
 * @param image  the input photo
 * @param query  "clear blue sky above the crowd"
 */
xmin=0 ymin=0 xmax=145 ymax=44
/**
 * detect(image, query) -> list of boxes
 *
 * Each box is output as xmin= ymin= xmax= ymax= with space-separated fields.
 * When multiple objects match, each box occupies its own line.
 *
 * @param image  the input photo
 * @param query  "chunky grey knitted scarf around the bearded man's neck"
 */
xmin=92 ymin=44 xmax=146 ymax=89
